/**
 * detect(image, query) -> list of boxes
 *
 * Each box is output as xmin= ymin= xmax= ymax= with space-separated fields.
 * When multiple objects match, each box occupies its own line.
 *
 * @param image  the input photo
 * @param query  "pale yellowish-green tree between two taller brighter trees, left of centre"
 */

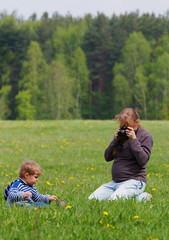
xmin=46 ymin=56 xmax=75 ymax=119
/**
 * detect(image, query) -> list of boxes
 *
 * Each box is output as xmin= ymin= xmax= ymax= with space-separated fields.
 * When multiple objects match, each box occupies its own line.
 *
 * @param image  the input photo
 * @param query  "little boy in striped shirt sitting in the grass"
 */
xmin=4 ymin=161 xmax=58 ymax=206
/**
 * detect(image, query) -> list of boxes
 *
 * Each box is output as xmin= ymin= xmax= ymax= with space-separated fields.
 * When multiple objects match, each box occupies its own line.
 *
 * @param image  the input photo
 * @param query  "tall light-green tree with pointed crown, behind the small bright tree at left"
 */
xmin=19 ymin=42 xmax=46 ymax=119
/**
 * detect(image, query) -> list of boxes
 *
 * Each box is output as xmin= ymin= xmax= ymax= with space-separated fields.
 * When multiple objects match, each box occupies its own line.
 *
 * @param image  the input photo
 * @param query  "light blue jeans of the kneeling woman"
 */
xmin=88 ymin=179 xmax=148 ymax=202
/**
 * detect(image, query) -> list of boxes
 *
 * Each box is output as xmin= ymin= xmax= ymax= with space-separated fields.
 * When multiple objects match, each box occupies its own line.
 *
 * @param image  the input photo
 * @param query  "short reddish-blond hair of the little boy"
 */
xmin=19 ymin=160 xmax=42 ymax=178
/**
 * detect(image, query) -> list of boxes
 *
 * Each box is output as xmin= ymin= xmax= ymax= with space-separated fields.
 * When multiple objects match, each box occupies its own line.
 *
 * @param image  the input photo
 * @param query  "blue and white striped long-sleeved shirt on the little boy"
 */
xmin=4 ymin=178 xmax=50 ymax=206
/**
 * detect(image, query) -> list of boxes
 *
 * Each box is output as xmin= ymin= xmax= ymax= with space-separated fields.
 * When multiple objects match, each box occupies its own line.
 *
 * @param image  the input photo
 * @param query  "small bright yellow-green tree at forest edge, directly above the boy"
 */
xmin=16 ymin=90 xmax=35 ymax=120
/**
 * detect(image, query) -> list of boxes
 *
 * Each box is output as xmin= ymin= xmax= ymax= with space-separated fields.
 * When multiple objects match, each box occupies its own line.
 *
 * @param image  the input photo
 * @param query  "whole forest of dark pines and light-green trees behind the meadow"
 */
xmin=0 ymin=11 xmax=169 ymax=120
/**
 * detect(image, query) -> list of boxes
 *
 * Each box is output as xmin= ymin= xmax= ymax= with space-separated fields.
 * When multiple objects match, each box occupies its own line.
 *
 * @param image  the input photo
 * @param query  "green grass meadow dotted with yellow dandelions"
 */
xmin=0 ymin=120 xmax=169 ymax=240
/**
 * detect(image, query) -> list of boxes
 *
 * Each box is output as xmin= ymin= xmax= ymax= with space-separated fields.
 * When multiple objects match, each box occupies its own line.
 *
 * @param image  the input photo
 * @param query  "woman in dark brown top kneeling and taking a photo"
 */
xmin=89 ymin=108 xmax=153 ymax=201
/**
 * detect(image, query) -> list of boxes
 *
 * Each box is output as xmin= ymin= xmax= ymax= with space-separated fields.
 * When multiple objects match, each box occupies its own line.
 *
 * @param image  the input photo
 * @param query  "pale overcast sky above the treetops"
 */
xmin=0 ymin=0 xmax=169 ymax=19
